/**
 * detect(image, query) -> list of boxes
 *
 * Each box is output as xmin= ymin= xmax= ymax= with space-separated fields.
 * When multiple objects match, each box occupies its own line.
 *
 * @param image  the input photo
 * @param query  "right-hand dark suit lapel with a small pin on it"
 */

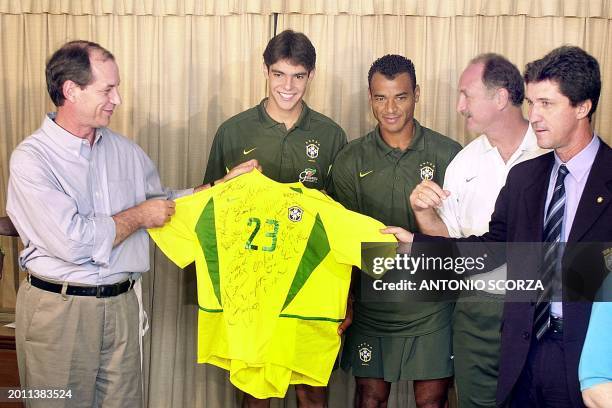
xmin=568 ymin=142 xmax=612 ymax=242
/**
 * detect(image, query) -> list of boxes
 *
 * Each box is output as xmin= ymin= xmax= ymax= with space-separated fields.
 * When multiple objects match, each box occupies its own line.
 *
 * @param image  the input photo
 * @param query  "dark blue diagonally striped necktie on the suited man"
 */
xmin=533 ymin=164 xmax=569 ymax=340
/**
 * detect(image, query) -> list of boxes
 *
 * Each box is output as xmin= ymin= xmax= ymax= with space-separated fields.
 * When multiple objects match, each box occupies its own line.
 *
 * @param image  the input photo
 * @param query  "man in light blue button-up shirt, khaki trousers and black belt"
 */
xmin=7 ymin=41 xmax=257 ymax=407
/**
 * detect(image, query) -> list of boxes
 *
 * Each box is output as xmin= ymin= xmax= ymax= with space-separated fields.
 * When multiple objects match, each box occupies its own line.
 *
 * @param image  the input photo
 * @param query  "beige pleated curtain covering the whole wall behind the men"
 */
xmin=0 ymin=0 xmax=612 ymax=407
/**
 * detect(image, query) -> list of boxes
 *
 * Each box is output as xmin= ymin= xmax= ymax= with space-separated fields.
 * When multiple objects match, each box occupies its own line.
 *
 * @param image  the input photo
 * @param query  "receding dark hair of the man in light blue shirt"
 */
xmin=45 ymin=40 xmax=115 ymax=106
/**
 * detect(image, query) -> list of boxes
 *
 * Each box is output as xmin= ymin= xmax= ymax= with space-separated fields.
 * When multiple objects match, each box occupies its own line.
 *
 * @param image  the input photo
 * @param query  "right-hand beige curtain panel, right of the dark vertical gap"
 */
xmin=278 ymin=14 xmax=612 ymax=144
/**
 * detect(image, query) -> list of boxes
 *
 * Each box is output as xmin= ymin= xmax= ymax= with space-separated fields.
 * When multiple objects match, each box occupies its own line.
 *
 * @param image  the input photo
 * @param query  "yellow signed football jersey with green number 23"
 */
xmin=149 ymin=171 xmax=395 ymax=398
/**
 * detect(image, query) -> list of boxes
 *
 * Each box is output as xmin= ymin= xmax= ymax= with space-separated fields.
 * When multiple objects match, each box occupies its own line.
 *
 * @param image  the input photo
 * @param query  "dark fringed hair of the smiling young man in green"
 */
xmin=263 ymin=30 xmax=317 ymax=72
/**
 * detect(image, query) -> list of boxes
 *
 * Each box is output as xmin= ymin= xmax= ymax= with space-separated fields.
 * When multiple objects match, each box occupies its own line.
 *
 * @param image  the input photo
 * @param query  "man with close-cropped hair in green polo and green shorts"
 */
xmin=330 ymin=55 xmax=461 ymax=408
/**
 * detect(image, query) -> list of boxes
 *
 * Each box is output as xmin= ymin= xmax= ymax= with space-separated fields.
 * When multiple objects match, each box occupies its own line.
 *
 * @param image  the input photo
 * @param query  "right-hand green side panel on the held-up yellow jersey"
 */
xmin=281 ymin=214 xmax=330 ymax=310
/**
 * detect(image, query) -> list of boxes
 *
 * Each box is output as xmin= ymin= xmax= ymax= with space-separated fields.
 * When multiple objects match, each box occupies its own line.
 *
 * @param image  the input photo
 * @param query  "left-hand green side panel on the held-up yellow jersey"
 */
xmin=196 ymin=198 xmax=223 ymax=305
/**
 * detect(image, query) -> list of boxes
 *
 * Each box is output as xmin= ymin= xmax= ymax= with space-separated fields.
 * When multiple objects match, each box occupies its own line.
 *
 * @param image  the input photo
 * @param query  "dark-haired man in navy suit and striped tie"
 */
xmin=384 ymin=46 xmax=612 ymax=407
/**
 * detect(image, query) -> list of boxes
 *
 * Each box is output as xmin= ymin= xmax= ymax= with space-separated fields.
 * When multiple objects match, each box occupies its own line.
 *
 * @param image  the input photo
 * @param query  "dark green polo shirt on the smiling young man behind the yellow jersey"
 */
xmin=204 ymin=98 xmax=346 ymax=190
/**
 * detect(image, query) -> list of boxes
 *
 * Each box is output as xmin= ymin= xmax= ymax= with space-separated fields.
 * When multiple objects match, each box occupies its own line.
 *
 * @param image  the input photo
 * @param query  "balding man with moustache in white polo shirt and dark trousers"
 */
xmin=410 ymin=54 xmax=544 ymax=408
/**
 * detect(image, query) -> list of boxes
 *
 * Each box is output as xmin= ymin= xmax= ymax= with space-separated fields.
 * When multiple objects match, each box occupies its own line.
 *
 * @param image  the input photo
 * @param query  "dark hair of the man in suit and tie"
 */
xmin=525 ymin=45 xmax=601 ymax=120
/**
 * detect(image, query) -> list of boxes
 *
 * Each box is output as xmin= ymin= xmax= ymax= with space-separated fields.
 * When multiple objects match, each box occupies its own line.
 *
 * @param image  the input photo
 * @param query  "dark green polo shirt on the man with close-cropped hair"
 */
xmin=329 ymin=120 xmax=461 ymax=336
